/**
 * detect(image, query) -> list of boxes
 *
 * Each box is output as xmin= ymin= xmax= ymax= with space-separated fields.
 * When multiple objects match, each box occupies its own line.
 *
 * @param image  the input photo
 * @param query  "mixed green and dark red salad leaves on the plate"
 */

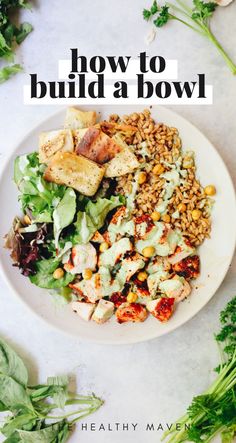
xmin=8 ymin=152 xmax=124 ymax=290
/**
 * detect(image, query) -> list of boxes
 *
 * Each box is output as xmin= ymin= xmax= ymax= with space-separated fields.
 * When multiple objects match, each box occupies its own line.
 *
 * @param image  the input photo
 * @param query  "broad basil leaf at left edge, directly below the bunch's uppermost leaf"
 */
xmin=0 ymin=374 xmax=32 ymax=410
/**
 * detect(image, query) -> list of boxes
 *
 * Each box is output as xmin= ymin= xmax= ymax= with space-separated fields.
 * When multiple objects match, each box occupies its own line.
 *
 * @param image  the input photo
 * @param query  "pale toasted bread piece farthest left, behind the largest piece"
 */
xmin=39 ymin=129 xmax=74 ymax=163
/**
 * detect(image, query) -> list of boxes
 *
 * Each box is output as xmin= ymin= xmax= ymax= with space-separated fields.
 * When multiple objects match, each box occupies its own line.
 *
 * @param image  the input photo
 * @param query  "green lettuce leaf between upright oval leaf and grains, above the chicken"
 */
xmin=74 ymin=197 xmax=123 ymax=244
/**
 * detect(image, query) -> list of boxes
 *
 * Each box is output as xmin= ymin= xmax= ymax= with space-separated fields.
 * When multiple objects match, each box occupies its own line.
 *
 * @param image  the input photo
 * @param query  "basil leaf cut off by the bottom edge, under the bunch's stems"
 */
xmin=19 ymin=420 xmax=69 ymax=443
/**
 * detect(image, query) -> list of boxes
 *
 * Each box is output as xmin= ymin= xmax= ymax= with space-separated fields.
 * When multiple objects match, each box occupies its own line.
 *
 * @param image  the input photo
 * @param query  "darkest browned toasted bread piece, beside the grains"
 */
xmin=75 ymin=127 xmax=122 ymax=164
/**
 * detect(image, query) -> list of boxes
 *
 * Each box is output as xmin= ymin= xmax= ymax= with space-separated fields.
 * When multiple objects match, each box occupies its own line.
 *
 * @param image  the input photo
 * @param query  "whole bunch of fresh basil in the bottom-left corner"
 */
xmin=0 ymin=339 xmax=103 ymax=443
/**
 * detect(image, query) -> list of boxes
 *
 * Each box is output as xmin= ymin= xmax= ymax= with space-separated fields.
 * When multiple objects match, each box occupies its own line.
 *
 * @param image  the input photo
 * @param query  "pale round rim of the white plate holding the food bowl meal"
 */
xmin=0 ymin=104 xmax=236 ymax=346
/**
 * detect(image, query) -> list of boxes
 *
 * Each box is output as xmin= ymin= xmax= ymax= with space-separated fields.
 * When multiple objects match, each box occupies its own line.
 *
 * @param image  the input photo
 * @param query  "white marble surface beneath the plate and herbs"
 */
xmin=0 ymin=0 xmax=236 ymax=443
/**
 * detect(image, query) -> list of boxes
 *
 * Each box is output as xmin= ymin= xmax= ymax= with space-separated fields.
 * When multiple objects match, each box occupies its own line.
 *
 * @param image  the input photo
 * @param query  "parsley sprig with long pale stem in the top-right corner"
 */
xmin=143 ymin=0 xmax=236 ymax=74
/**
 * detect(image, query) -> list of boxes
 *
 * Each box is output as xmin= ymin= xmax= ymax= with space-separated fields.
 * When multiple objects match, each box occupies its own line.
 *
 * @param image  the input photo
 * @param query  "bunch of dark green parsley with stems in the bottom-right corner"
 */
xmin=162 ymin=297 xmax=236 ymax=443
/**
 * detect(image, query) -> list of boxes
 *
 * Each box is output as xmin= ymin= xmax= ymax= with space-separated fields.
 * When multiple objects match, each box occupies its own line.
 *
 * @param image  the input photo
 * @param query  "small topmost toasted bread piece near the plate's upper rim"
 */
xmin=64 ymin=107 xmax=97 ymax=129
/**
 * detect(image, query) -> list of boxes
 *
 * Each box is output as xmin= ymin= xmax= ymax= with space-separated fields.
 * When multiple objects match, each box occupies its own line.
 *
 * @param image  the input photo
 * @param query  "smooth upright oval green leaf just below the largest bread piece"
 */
xmin=53 ymin=188 xmax=76 ymax=248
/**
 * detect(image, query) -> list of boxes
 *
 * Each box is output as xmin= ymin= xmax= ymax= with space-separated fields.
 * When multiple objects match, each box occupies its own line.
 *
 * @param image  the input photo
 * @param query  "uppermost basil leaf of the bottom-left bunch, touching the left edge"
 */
xmin=0 ymin=339 xmax=28 ymax=386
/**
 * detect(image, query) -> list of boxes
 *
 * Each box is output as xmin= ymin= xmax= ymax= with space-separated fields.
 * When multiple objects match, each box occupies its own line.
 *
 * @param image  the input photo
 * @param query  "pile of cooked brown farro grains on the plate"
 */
xmin=110 ymin=109 xmax=212 ymax=246
